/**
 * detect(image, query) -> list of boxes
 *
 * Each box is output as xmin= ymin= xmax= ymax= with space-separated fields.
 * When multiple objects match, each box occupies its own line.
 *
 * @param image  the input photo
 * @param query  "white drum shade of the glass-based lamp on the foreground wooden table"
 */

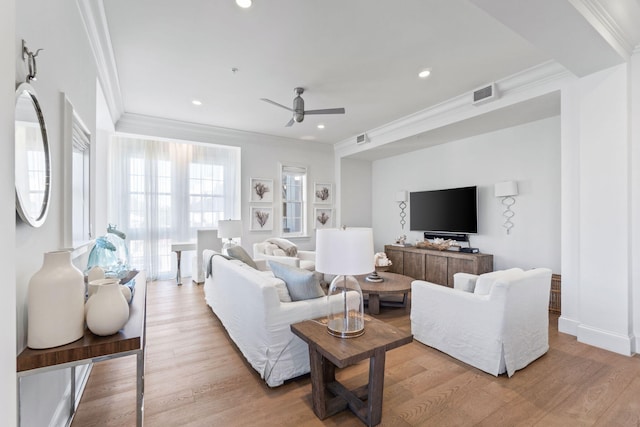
xmin=316 ymin=227 xmax=375 ymax=275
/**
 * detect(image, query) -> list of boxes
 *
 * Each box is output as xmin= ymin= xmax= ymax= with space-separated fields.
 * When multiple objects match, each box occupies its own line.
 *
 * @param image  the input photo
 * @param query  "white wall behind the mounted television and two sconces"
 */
xmin=372 ymin=117 xmax=560 ymax=273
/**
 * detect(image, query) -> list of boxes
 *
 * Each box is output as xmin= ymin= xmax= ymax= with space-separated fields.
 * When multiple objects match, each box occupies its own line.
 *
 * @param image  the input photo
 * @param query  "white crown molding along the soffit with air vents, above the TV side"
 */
xmin=334 ymin=61 xmax=575 ymax=157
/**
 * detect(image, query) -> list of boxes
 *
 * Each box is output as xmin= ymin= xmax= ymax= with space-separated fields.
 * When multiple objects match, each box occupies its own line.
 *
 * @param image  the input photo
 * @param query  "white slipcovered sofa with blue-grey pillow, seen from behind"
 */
xmin=203 ymin=250 xmax=350 ymax=387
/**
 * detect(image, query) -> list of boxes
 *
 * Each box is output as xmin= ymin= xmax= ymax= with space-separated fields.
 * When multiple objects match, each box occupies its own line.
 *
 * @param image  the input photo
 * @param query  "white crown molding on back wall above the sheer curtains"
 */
xmin=116 ymin=113 xmax=333 ymax=151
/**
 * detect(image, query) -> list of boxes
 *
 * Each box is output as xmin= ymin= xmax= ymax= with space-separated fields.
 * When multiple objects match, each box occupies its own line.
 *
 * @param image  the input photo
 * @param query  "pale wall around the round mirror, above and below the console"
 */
xmin=14 ymin=0 xmax=96 ymax=425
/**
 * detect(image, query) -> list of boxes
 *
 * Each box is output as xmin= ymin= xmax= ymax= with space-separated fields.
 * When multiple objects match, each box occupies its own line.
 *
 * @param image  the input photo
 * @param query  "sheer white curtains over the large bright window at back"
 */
xmin=109 ymin=136 xmax=240 ymax=279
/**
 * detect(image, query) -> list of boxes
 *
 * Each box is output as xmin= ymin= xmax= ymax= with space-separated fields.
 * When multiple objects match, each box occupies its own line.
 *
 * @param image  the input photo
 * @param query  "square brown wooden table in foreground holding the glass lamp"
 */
xmin=291 ymin=316 xmax=413 ymax=426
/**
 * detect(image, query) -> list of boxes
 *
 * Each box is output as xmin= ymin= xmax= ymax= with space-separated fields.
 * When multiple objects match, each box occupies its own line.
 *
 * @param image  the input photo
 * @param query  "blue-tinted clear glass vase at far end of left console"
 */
xmin=85 ymin=224 xmax=130 ymax=279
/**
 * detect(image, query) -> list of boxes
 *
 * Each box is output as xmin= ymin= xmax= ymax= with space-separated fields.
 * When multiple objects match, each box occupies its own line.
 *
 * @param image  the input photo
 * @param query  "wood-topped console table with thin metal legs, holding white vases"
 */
xmin=17 ymin=272 xmax=147 ymax=427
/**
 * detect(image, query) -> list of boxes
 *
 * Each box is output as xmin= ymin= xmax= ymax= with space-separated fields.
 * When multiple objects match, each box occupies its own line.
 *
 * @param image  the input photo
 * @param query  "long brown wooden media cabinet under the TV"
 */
xmin=384 ymin=245 xmax=493 ymax=288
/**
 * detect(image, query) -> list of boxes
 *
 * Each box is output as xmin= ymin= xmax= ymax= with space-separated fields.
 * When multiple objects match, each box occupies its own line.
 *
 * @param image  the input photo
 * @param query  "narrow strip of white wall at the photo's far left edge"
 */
xmin=0 ymin=0 xmax=18 ymax=426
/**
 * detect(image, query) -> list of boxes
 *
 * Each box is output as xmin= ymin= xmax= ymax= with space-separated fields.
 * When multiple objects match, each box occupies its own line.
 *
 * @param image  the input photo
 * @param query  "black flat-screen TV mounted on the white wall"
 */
xmin=409 ymin=186 xmax=478 ymax=233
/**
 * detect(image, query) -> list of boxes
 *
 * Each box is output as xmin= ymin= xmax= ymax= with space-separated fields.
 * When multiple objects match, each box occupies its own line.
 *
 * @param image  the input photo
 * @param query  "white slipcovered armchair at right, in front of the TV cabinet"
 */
xmin=411 ymin=268 xmax=551 ymax=376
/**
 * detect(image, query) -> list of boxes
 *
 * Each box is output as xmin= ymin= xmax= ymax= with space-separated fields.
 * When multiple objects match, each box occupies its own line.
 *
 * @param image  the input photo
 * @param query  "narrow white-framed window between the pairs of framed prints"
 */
xmin=280 ymin=165 xmax=307 ymax=237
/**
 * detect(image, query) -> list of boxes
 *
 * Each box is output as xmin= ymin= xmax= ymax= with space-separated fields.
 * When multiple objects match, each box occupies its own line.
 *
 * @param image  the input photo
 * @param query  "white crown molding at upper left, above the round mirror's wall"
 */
xmin=77 ymin=0 xmax=124 ymax=123
